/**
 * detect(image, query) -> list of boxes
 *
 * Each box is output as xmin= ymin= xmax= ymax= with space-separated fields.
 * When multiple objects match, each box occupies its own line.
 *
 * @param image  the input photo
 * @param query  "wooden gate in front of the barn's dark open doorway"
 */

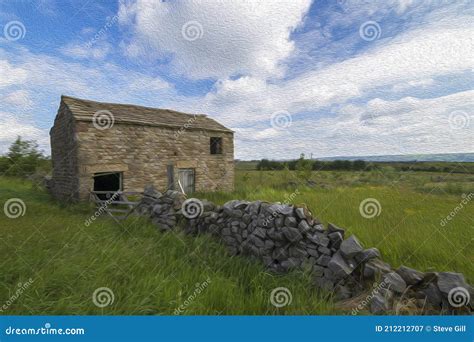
xmin=91 ymin=191 xmax=143 ymax=222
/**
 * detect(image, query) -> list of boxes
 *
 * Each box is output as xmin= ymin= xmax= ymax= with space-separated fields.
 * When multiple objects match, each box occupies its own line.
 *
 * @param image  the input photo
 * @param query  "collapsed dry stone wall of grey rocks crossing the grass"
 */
xmin=139 ymin=186 xmax=474 ymax=314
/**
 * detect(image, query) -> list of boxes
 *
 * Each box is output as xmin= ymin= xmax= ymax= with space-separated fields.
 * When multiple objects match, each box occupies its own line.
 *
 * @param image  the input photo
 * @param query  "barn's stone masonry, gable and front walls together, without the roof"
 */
xmin=50 ymin=96 xmax=234 ymax=200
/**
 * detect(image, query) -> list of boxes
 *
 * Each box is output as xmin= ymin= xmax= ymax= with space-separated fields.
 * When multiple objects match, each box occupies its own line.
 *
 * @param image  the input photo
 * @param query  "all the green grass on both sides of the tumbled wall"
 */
xmin=0 ymin=171 xmax=474 ymax=315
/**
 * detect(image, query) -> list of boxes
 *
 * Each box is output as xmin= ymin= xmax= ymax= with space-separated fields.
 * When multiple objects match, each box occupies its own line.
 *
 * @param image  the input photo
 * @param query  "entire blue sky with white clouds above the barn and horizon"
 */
xmin=0 ymin=0 xmax=474 ymax=159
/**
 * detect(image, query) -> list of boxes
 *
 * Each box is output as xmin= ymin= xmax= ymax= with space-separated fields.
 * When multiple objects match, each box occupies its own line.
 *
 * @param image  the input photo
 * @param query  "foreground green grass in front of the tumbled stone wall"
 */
xmin=0 ymin=178 xmax=334 ymax=315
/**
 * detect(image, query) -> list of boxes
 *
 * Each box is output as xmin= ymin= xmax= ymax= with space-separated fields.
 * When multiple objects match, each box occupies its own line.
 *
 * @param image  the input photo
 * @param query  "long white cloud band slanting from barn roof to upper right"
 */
xmin=195 ymin=17 xmax=474 ymax=131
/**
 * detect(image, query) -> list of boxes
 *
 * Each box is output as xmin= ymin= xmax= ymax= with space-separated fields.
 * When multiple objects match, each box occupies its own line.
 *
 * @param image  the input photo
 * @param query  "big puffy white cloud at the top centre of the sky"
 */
xmin=119 ymin=0 xmax=310 ymax=79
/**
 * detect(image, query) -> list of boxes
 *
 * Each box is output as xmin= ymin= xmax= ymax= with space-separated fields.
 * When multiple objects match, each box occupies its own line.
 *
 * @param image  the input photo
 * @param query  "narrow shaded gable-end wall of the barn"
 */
xmin=50 ymin=103 xmax=79 ymax=200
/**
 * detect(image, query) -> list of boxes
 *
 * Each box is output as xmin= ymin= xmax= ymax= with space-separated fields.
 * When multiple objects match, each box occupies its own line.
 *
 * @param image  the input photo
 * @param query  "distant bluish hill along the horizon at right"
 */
xmin=313 ymin=153 xmax=474 ymax=162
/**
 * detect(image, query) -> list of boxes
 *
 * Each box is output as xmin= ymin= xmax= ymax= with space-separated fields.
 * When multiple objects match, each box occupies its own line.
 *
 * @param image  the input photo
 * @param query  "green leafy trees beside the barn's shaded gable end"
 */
xmin=0 ymin=137 xmax=51 ymax=178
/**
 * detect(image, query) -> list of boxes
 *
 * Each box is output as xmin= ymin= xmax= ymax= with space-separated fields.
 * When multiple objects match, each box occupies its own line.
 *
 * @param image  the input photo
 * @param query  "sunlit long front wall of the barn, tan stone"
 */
xmin=76 ymin=121 xmax=234 ymax=198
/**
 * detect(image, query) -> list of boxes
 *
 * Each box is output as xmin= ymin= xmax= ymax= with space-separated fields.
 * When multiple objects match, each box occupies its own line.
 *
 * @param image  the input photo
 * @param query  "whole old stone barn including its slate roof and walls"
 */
xmin=50 ymin=96 xmax=234 ymax=200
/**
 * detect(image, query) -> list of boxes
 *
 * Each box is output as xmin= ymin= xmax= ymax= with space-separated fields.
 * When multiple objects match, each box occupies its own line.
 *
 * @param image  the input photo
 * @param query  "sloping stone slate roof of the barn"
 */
xmin=61 ymin=95 xmax=233 ymax=132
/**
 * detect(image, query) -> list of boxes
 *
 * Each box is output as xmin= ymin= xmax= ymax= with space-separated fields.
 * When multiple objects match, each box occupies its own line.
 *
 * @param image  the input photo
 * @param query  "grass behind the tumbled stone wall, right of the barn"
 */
xmin=200 ymin=171 xmax=474 ymax=283
